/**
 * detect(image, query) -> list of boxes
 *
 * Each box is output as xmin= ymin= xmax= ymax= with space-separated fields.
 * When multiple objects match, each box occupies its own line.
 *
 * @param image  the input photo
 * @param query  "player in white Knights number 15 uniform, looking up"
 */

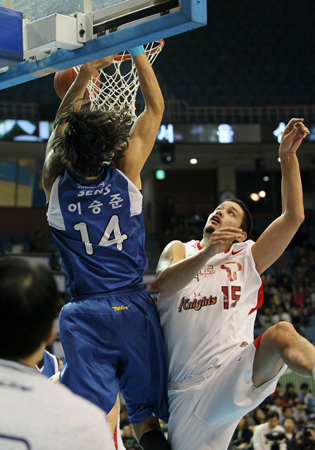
xmin=157 ymin=119 xmax=315 ymax=450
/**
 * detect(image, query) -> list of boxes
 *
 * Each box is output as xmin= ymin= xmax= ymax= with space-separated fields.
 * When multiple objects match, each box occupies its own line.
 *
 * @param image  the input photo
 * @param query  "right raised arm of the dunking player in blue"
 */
xmin=118 ymin=48 xmax=164 ymax=189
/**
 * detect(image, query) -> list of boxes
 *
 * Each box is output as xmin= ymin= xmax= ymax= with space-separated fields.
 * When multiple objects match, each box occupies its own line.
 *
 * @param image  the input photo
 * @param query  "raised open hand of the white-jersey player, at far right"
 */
xmin=279 ymin=118 xmax=310 ymax=157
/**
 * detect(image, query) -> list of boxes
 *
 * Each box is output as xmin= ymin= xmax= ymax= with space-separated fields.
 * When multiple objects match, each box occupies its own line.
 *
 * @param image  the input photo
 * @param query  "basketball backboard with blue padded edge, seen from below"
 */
xmin=0 ymin=0 xmax=207 ymax=89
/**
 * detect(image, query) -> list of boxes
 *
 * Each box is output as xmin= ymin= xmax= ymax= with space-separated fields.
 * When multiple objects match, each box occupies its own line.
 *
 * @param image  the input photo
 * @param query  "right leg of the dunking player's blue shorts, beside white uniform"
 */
xmin=120 ymin=299 xmax=168 ymax=423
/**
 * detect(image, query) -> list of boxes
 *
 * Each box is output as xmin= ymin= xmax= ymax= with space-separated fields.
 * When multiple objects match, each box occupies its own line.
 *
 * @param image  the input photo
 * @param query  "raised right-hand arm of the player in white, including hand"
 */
xmin=252 ymin=119 xmax=309 ymax=273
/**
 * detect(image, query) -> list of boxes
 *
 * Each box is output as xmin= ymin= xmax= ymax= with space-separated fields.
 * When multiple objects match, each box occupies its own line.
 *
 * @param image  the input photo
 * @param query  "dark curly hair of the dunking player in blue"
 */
xmin=53 ymin=99 xmax=133 ymax=175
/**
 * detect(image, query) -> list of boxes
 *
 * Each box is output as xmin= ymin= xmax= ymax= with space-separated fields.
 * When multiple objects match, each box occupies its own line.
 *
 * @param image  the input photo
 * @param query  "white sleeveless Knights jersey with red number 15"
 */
xmin=157 ymin=240 xmax=262 ymax=382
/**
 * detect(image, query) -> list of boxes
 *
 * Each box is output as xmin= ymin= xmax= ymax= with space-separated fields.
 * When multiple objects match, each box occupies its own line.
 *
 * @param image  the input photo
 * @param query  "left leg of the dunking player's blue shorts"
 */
xmin=60 ymin=302 xmax=122 ymax=412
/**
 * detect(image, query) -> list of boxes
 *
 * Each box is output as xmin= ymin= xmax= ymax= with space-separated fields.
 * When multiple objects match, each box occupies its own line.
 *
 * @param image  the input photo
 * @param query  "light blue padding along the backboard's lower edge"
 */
xmin=0 ymin=0 xmax=207 ymax=89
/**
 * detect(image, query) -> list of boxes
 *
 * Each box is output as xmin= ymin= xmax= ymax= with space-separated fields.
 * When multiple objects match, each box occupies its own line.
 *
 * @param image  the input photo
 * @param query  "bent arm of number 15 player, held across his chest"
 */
xmin=156 ymin=227 xmax=244 ymax=295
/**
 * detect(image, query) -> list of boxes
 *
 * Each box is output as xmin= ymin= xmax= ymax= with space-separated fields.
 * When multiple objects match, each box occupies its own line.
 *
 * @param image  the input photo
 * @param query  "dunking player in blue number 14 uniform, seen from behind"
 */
xmin=43 ymin=47 xmax=170 ymax=450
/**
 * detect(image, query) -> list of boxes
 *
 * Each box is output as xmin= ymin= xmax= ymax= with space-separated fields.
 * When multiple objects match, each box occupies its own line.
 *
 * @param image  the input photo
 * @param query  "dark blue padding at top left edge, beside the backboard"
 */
xmin=0 ymin=8 xmax=23 ymax=67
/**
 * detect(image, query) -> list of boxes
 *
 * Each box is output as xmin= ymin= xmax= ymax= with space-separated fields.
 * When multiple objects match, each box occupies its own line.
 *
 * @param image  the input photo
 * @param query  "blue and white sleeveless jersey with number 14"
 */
xmin=47 ymin=168 xmax=147 ymax=297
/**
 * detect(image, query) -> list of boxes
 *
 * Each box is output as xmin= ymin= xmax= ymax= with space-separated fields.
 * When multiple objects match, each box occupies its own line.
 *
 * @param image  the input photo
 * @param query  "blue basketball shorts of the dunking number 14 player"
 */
xmin=60 ymin=285 xmax=169 ymax=423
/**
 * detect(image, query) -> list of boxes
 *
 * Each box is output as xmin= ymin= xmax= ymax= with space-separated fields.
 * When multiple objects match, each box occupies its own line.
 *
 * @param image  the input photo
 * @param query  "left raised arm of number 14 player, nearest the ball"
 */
xmin=43 ymin=56 xmax=114 ymax=201
